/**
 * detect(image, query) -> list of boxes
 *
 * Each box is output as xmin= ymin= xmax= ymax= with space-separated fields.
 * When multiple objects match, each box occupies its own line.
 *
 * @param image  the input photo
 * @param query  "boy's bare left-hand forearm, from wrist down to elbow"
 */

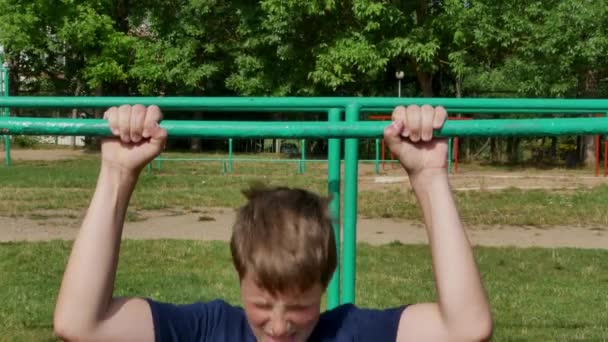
xmin=55 ymin=165 xmax=136 ymax=330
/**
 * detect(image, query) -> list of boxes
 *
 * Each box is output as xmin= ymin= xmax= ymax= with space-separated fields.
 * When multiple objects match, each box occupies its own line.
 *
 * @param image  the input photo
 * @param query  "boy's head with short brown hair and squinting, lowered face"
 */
xmin=230 ymin=186 xmax=337 ymax=341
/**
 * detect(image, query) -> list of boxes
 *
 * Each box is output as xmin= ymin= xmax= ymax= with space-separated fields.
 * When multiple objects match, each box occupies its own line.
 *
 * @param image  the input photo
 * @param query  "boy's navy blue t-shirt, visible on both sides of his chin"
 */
xmin=148 ymin=300 xmax=405 ymax=342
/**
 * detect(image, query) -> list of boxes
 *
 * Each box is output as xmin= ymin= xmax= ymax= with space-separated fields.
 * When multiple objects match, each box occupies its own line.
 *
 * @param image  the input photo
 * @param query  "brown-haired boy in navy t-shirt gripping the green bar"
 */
xmin=54 ymin=106 xmax=492 ymax=341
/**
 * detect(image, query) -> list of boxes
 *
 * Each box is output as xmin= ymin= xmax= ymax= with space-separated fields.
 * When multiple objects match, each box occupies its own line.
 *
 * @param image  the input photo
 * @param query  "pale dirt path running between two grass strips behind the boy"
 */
xmin=0 ymin=209 xmax=608 ymax=248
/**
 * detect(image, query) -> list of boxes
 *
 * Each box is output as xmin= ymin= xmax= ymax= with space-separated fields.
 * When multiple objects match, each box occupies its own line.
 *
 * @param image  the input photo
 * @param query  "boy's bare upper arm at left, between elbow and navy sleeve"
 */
xmin=94 ymin=298 xmax=154 ymax=341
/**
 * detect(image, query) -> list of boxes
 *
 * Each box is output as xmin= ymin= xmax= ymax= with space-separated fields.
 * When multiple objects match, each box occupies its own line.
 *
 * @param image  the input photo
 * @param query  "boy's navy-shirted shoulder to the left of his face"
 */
xmin=147 ymin=299 xmax=251 ymax=341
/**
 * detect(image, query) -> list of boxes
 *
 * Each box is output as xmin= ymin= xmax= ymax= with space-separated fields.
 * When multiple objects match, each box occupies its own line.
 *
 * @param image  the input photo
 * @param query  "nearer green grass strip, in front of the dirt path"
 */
xmin=0 ymin=241 xmax=608 ymax=341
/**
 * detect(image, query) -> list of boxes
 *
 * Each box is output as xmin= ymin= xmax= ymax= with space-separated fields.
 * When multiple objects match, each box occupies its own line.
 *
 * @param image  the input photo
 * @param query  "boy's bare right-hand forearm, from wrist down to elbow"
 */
xmin=412 ymin=169 xmax=491 ymax=331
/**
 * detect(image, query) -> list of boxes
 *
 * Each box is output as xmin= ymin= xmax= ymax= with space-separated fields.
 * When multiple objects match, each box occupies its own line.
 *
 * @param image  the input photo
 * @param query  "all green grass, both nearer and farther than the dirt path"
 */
xmin=0 ymin=150 xmax=608 ymax=341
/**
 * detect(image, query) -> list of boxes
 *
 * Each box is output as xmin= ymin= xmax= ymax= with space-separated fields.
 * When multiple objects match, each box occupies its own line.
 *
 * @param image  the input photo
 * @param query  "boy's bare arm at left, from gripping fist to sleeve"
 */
xmin=53 ymin=106 xmax=166 ymax=341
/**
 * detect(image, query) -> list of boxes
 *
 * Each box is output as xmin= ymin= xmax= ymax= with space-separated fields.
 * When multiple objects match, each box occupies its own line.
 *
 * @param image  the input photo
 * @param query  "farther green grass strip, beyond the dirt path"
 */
xmin=0 ymin=153 xmax=608 ymax=226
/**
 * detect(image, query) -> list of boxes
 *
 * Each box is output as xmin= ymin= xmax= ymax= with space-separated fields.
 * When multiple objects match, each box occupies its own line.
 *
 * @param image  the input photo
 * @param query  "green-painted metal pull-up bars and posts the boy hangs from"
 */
xmin=0 ymin=97 xmax=608 ymax=308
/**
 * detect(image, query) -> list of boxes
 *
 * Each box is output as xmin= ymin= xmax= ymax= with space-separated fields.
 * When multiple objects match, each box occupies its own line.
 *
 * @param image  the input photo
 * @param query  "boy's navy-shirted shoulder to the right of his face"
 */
xmin=311 ymin=304 xmax=406 ymax=341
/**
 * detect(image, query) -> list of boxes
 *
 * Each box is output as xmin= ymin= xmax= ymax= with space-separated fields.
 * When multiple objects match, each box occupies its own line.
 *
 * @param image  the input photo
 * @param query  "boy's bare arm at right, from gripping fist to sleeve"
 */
xmin=385 ymin=106 xmax=492 ymax=341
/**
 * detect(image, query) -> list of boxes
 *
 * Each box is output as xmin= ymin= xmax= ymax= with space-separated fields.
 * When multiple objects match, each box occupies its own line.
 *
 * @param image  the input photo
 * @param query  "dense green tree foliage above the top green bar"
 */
xmin=0 ymin=0 xmax=608 ymax=97
